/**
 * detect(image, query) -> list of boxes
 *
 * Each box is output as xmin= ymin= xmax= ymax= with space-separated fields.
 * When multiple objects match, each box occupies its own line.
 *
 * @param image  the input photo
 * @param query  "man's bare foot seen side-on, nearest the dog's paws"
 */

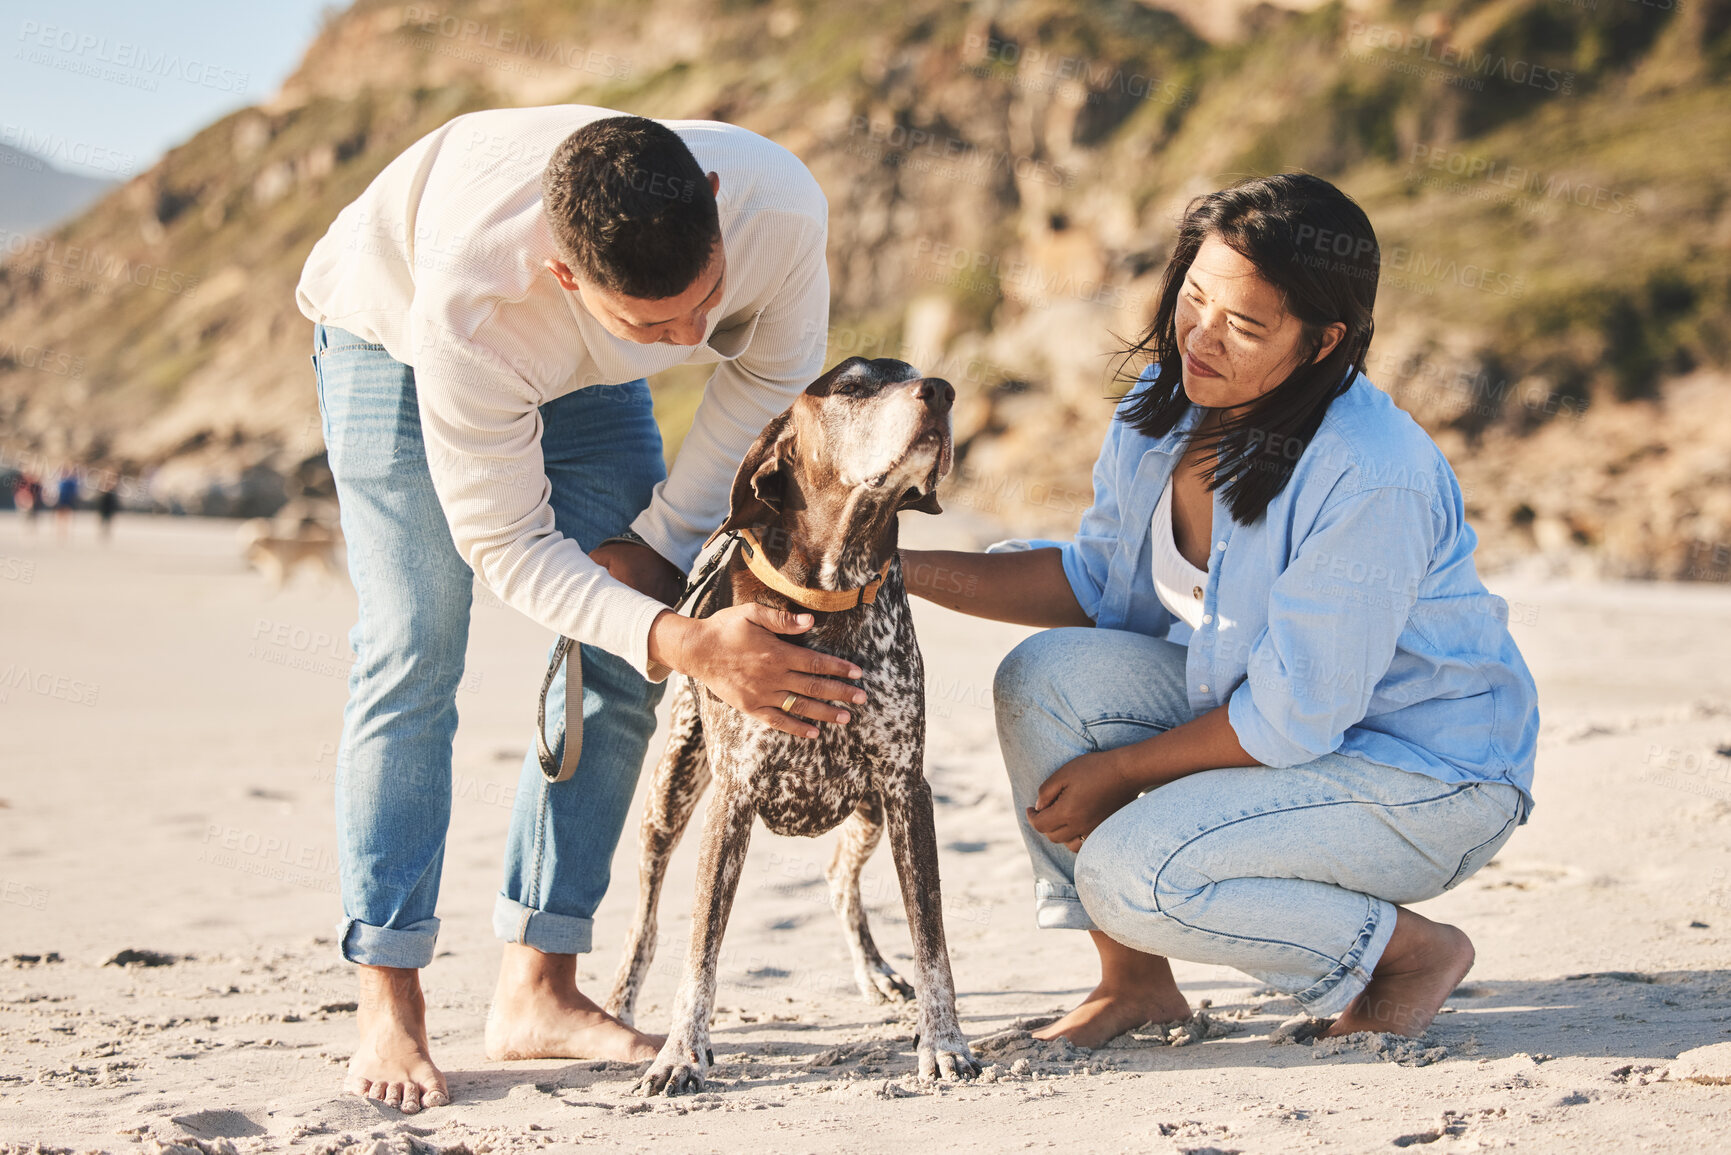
xmin=486 ymin=942 xmax=663 ymax=1063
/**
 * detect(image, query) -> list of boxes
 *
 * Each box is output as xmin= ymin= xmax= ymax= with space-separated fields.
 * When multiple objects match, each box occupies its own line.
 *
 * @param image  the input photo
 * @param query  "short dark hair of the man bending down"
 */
xmin=542 ymin=116 xmax=722 ymax=300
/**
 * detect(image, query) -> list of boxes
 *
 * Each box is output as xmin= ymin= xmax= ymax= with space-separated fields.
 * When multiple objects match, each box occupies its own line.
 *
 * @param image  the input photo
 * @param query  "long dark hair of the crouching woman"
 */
xmin=1118 ymin=173 xmax=1381 ymax=525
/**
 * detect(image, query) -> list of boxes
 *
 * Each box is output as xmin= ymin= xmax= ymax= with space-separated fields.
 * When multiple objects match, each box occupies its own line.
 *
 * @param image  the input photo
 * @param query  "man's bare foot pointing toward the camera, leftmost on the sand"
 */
xmin=343 ymin=966 xmax=450 ymax=1115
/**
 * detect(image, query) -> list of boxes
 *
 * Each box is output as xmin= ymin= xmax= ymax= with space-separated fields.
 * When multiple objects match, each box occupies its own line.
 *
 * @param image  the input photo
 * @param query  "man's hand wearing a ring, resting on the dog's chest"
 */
xmin=649 ymin=601 xmax=866 ymax=738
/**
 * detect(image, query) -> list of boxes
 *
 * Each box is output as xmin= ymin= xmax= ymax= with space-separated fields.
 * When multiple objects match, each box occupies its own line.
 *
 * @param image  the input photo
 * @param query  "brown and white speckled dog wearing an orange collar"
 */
xmin=608 ymin=357 xmax=980 ymax=1094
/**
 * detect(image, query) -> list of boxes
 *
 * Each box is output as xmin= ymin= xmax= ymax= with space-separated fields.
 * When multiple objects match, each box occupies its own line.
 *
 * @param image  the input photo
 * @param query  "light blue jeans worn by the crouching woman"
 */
xmin=995 ymin=629 xmax=1523 ymax=1018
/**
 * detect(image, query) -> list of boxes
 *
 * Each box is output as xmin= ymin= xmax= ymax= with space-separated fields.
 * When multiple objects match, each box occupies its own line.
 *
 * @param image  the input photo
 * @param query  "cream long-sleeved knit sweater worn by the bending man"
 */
xmin=296 ymin=104 xmax=829 ymax=675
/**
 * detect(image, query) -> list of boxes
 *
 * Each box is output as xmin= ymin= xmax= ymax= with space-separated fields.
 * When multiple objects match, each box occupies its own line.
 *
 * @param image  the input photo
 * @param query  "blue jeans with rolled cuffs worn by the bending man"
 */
xmin=313 ymin=326 xmax=666 ymax=966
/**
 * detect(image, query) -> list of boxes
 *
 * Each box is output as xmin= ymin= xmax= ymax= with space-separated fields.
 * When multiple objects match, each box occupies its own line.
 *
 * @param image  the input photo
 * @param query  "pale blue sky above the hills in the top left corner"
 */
xmin=0 ymin=0 xmax=343 ymax=178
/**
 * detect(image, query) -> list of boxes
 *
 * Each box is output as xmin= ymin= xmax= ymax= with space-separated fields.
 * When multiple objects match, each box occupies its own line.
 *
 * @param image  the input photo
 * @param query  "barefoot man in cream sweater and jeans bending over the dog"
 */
xmin=298 ymin=106 xmax=857 ymax=1112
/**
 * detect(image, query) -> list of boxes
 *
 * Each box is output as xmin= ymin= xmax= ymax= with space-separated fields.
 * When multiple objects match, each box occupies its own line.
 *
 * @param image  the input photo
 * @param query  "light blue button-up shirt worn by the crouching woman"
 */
xmin=1042 ymin=374 xmax=1539 ymax=810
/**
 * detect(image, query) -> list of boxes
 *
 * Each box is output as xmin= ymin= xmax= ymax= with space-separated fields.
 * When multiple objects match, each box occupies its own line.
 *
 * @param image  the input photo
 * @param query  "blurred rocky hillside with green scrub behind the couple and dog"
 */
xmin=0 ymin=0 xmax=1731 ymax=580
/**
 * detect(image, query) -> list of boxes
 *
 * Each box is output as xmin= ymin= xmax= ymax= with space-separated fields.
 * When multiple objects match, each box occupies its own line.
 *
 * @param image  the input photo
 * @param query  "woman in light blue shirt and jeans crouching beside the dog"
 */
xmin=902 ymin=175 xmax=1539 ymax=1048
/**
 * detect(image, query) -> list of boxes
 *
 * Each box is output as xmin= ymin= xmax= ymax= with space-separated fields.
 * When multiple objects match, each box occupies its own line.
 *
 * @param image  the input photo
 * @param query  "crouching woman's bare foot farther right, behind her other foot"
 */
xmin=1328 ymin=907 xmax=1473 ymax=1039
